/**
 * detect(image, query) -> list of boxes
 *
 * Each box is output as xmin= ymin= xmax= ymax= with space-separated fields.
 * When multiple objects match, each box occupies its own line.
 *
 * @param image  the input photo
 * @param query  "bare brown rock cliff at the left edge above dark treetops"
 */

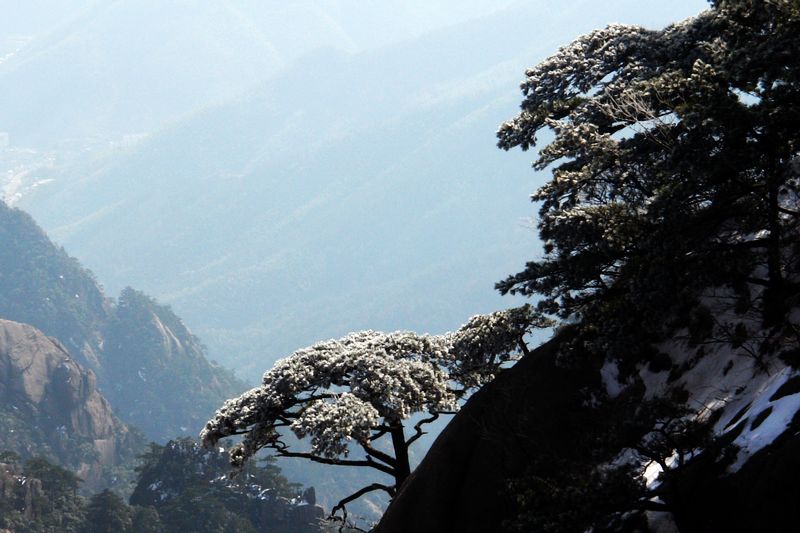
xmin=0 ymin=319 xmax=136 ymax=490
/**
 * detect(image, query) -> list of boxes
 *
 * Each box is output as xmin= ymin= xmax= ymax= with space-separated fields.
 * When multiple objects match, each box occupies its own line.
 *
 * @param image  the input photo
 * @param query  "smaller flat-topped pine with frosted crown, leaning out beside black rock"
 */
xmin=201 ymin=305 xmax=552 ymax=520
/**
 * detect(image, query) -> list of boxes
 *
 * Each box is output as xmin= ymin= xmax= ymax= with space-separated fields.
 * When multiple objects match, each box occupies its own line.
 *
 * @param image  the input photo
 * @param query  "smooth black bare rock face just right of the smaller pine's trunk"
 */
xmin=376 ymin=336 xmax=586 ymax=533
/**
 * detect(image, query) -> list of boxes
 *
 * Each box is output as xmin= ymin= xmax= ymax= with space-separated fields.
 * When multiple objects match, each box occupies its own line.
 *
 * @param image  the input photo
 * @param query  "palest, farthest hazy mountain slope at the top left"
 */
xmin=0 ymin=0 xmax=520 ymax=147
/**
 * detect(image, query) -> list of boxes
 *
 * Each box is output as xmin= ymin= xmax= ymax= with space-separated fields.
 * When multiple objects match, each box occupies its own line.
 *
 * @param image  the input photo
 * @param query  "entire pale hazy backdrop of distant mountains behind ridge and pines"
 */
xmin=0 ymin=0 xmax=707 ymax=375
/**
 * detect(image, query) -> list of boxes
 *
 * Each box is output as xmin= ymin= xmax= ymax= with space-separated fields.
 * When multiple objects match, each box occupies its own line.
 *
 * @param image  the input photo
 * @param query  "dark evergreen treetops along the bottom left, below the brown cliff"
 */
xmin=0 ymin=439 xmax=312 ymax=533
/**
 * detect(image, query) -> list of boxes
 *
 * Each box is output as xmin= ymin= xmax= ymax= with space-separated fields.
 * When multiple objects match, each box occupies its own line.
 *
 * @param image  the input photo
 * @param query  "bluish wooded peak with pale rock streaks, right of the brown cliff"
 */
xmin=102 ymin=287 xmax=243 ymax=442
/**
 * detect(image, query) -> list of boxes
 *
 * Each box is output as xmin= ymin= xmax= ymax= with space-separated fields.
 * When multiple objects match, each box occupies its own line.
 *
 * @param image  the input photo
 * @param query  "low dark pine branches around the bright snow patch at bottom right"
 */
xmin=505 ymin=386 xmax=730 ymax=533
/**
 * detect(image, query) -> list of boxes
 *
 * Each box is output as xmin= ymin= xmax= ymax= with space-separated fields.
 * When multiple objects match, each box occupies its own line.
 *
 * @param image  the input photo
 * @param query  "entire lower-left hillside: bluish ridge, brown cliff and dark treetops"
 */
xmin=0 ymin=203 xmax=324 ymax=533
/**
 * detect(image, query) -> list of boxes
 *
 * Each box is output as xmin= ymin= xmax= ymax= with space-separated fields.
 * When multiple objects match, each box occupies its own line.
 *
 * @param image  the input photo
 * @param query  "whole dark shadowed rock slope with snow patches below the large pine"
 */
xmin=375 ymin=328 xmax=800 ymax=533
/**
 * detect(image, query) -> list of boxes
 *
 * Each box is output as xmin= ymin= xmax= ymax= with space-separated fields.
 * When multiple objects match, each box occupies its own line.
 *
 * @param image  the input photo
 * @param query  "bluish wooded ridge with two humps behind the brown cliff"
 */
xmin=0 ymin=202 xmax=244 ymax=441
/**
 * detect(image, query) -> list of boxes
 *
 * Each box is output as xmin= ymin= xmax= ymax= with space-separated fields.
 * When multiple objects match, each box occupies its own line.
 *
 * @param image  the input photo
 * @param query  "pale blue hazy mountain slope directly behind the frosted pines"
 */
xmin=17 ymin=2 xmax=703 ymax=376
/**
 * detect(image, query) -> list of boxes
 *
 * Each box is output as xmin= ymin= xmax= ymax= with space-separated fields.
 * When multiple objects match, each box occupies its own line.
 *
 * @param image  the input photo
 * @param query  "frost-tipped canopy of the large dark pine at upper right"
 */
xmin=498 ymin=0 xmax=800 ymax=336
